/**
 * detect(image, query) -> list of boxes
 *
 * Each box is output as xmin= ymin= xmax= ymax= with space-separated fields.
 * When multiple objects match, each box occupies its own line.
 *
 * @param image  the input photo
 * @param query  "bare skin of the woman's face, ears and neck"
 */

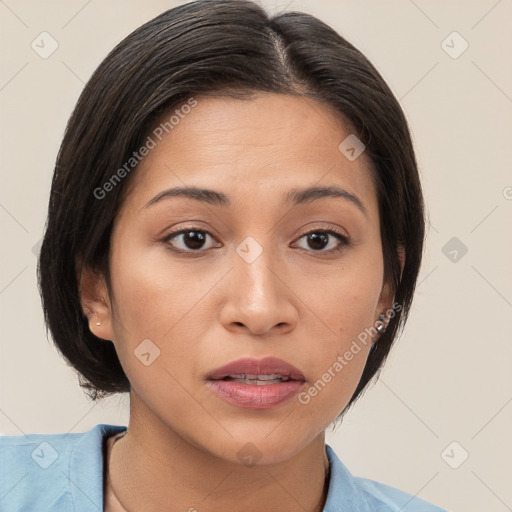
xmin=80 ymin=94 xmax=402 ymax=512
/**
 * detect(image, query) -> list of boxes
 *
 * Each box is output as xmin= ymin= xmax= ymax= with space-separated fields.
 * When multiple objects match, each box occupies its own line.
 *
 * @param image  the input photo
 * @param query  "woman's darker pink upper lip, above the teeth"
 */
xmin=207 ymin=357 xmax=305 ymax=380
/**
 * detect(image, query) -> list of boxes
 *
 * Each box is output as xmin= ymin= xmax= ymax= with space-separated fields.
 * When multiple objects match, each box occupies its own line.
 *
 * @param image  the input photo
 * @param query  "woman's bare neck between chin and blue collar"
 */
xmin=108 ymin=391 xmax=328 ymax=512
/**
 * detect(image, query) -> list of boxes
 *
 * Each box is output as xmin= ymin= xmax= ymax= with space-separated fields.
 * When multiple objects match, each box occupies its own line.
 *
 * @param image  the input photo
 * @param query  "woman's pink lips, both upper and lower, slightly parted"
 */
xmin=207 ymin=357 xmax=306 ymax=409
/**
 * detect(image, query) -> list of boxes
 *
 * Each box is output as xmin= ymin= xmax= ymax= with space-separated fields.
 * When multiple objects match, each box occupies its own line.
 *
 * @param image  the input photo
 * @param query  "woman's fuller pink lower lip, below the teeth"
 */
xmin=208 ymin=380 xmax=305 ymax=409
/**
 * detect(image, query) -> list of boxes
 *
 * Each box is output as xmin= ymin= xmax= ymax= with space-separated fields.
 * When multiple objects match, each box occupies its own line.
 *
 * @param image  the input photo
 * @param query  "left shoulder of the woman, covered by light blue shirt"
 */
xmin=0 ymin=424 xmax=126 ymax=511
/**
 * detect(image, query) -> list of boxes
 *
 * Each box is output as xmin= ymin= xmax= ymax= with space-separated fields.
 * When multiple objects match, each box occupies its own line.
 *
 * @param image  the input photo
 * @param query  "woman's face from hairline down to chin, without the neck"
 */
xmin=87 ymin=94 xmax=392 ymax=463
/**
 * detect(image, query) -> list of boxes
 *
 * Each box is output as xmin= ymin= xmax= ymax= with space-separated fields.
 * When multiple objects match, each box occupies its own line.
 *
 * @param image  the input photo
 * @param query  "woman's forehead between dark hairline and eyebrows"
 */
xmin=120 ymin=94 xmax=377 ymax=213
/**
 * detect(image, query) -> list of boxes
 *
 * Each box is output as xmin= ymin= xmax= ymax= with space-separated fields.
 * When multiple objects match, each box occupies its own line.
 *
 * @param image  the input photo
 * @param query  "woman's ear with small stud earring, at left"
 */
xmin=78 ymin=268 xmax=114 ymax=340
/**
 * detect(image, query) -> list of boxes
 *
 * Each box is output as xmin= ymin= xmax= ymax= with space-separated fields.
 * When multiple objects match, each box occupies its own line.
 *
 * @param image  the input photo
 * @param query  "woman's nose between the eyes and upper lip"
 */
xmin=220 ymin=244 xmax=298 ymax=336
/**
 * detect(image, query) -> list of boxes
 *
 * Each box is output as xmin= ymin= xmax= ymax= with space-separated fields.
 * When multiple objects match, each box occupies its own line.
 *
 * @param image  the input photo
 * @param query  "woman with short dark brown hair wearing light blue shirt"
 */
xmin=0 ymin=0 xmax=441 ymax=512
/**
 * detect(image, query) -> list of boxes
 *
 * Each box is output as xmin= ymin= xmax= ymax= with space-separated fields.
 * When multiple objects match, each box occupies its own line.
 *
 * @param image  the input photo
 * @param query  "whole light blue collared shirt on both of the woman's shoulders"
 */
xmin=0 ymin=424 xmax=446 ymax=512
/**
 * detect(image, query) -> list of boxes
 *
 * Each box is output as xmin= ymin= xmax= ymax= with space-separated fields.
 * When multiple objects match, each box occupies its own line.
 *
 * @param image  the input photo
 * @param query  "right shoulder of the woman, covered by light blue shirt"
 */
xmin=324 ymin=445 xmax=447 ymax=512
